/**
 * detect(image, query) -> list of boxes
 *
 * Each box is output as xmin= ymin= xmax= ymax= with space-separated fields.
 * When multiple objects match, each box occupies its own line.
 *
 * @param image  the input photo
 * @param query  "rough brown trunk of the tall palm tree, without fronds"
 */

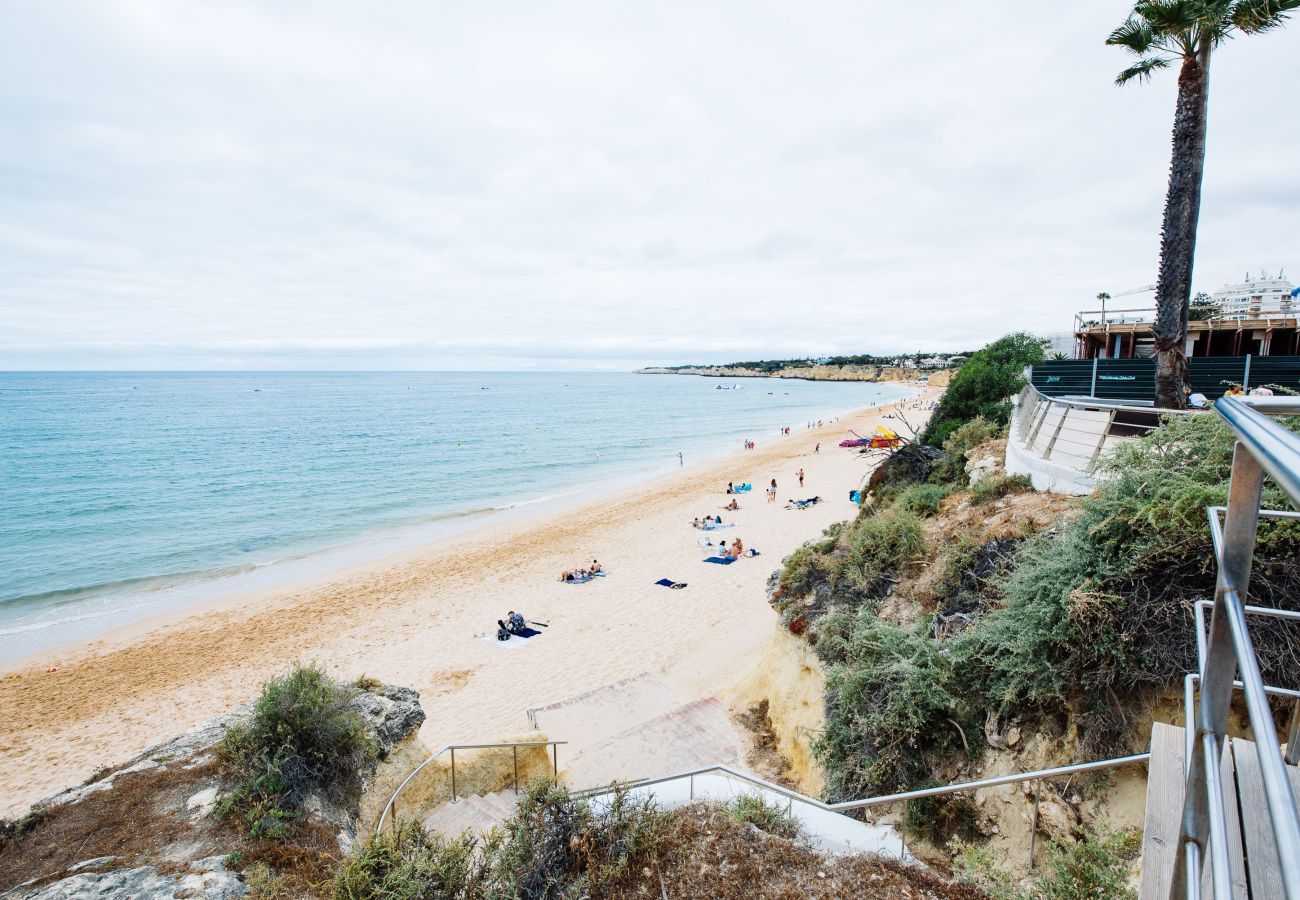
xmin=1152 ymin=48 xmax=1210 ymax=410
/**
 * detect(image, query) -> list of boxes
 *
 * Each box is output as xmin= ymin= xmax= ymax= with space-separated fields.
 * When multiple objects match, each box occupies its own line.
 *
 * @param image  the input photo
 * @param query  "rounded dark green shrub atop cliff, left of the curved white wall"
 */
xmin=920 ymin=332 xmax=1045 ymax=446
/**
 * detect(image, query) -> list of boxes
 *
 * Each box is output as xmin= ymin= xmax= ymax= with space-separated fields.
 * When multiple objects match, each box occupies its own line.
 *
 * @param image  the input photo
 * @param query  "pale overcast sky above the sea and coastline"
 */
xmin=0 ymin=0 xmax=1300 ymax=369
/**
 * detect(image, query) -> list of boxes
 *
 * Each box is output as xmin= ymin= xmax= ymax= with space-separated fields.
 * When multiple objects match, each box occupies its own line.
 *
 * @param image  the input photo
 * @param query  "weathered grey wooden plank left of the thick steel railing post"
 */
xmin=1138 ymin=722 xmax=1184 ymax=900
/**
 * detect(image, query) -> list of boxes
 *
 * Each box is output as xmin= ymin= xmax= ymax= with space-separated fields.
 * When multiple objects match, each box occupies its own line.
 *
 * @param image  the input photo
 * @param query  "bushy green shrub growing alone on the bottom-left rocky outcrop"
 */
xmin=216 ymin=666 xmax=374 ymax=838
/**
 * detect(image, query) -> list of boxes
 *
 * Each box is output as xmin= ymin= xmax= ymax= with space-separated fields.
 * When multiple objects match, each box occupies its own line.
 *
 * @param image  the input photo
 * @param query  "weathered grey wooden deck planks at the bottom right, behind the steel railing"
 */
xmin=1139 ymin=722 xmax=1300 ymax=900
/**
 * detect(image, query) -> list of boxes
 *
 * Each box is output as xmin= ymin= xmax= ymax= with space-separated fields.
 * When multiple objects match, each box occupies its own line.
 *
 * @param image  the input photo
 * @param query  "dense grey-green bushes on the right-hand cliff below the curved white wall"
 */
xmin=775 ymin=403 xmax=1300 ymax=800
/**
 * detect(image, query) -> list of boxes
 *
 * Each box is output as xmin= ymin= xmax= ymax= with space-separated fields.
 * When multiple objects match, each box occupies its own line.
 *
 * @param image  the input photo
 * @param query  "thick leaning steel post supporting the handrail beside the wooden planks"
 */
xmin=1170 ymin=441 xmax=1264 ymax=897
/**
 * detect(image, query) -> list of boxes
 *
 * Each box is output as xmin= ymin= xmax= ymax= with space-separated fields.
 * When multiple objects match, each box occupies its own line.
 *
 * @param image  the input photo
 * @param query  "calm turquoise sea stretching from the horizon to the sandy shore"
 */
xmin=0 ymin=372 xmax=907 ymax=659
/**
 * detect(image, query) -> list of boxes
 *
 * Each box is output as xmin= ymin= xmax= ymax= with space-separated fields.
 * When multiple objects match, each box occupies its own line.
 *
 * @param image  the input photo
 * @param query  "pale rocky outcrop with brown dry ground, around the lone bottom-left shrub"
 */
xmin=0 ymin=685 xmax=425 ymax=900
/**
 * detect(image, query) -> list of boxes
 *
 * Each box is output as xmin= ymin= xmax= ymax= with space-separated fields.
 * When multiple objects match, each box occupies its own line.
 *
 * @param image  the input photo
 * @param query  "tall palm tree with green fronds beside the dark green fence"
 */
xmin=1106 ymin=0 xmax=1300 ymax=410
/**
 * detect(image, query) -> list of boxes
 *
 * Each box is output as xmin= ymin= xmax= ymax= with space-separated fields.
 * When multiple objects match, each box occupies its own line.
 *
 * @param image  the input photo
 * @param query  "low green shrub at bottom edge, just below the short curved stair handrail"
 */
xmin=334 ymin=822 xmax=485 ymax=900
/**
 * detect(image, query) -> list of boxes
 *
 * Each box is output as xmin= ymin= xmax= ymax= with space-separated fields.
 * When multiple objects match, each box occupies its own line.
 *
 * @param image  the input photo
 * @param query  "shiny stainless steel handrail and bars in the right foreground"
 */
xmin=1170 ymin=397 xmax=1300 ymax=900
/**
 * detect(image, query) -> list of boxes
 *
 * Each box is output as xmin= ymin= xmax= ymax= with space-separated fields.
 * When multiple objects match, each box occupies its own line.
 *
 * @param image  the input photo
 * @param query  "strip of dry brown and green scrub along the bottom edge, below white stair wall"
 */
xmin=333 ymin=782 xmax=983 ymax=900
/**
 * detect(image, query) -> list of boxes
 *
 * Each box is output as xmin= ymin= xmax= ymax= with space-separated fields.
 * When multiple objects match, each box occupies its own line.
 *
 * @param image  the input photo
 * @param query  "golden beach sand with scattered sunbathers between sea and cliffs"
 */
xmin=0 ymin=389 xmax=940 ymax=817
